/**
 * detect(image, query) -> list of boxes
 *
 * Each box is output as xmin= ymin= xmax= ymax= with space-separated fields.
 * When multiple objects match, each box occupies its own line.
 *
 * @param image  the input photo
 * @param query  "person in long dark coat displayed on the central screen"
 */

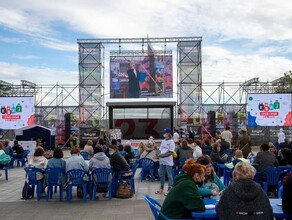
xmin=127 ymin=61 xmax=140 ymax=98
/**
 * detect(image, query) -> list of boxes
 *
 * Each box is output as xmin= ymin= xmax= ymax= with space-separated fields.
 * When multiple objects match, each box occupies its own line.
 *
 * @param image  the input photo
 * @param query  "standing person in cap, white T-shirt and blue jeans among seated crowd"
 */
xmin=155 ymin=128 xmax=175 ymax=196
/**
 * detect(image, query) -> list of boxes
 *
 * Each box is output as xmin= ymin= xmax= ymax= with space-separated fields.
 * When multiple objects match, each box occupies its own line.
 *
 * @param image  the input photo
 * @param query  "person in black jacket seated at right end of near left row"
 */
xmin=109 ymin=145 xmax=131 ymax=179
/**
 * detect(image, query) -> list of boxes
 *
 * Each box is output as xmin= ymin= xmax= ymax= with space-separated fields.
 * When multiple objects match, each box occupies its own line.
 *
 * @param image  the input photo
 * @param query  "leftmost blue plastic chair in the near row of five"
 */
xmin=24 ymin=167 xmax=45 ymax=201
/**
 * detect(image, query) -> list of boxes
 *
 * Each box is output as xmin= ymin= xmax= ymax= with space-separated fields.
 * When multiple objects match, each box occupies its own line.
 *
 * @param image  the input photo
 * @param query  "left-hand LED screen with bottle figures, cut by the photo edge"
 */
xmin=0 ymin=97 xmax=34 ymax=129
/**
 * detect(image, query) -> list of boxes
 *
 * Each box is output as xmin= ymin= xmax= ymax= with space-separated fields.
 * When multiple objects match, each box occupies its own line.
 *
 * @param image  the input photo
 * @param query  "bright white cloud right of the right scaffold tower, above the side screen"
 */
xmin=203 ymin=46 xmax=292 ymax=82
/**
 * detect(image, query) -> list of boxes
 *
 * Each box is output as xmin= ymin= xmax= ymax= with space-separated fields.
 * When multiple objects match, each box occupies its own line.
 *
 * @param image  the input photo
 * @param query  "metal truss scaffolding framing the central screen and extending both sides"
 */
xmin=0 ymin=37 xmax=291 ymax=144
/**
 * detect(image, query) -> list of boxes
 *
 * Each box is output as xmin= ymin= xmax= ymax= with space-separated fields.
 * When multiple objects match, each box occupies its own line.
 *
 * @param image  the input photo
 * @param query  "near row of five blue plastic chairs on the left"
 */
xmin=24 ymin=161 xmax=138 ymax=202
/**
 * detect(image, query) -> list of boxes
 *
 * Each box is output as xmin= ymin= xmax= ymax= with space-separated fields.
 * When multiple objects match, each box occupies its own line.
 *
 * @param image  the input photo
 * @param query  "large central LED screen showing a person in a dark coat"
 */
xmin=110 ymin=55 xmax=173 ymax=98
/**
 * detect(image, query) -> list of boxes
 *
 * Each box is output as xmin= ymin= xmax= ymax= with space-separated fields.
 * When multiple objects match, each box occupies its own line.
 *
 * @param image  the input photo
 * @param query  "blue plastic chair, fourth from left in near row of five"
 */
xmin=91 ymin=168 xmax=113 ymax=200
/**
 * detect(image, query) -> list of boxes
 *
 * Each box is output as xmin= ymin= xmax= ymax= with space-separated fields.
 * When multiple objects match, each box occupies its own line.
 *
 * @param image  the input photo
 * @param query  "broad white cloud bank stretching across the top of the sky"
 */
xmin=0 ymin=0 xmax=292 ymax=40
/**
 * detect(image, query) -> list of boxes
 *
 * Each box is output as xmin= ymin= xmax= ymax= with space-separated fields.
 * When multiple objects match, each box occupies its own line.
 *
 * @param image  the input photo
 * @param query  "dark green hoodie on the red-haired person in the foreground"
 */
xmin=160 ymin=174 xmax=205 ymax=219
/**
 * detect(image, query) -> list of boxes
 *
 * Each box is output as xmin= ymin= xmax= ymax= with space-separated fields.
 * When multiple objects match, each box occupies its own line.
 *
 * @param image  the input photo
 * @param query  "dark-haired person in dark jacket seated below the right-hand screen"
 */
xmin=253 ymin=143 xmax=279 ymax=172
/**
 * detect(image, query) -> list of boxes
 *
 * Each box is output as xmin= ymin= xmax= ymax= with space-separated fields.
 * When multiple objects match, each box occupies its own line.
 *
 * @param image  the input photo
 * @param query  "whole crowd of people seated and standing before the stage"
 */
xmin=0 ymin=127 xmax=292 ymax=219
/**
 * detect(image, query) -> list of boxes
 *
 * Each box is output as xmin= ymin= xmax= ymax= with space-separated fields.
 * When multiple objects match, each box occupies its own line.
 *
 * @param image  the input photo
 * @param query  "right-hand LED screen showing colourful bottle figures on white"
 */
xmin=247 ymin=93 xmax=292 ymax=126
